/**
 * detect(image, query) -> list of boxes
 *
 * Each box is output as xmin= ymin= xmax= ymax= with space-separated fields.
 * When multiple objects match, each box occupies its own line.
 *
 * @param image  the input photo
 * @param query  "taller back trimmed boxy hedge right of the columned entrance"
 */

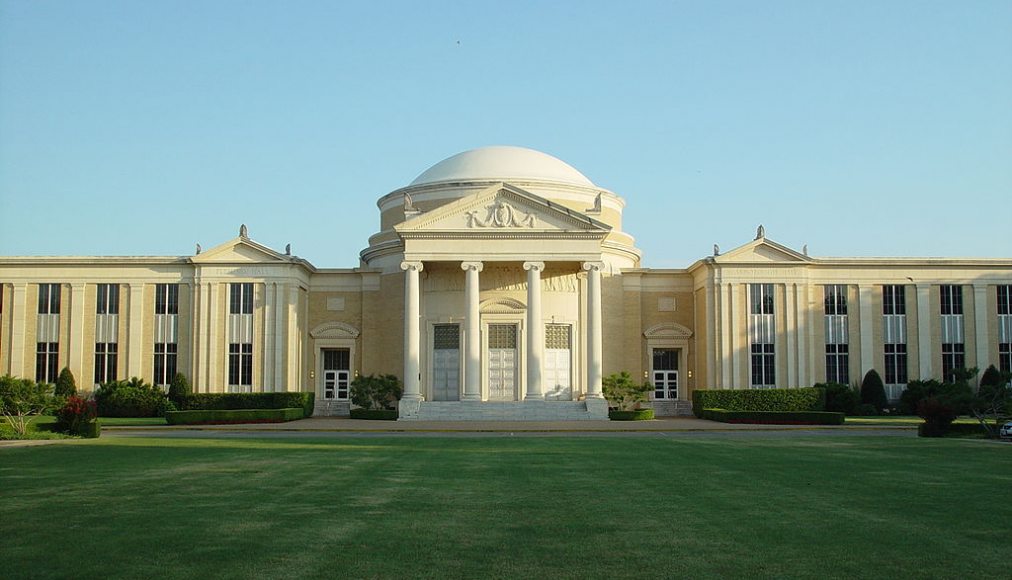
xmin=692 ymin=387 xmax=826 ymax=418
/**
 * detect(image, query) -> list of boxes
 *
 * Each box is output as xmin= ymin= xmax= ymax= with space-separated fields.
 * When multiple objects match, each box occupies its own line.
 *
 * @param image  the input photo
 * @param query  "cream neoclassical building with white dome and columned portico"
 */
xmin=0 ymin=147 xmax=1012 ymax=420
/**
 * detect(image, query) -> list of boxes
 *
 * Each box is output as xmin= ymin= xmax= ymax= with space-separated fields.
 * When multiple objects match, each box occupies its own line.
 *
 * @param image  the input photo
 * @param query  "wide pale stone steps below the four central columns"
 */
xmin=399 ymin=399 xmax=608 ymax=421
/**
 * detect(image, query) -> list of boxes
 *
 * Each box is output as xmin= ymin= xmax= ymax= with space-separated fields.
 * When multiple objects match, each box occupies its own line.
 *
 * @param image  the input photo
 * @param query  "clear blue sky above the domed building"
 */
xmin=0 ymin=0 xmax=1012 ymax=267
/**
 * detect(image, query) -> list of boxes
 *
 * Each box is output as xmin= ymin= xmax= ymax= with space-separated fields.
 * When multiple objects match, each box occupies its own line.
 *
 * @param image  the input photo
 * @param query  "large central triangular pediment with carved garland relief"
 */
xmin=394 ymin=183 xmax=611 ymax=237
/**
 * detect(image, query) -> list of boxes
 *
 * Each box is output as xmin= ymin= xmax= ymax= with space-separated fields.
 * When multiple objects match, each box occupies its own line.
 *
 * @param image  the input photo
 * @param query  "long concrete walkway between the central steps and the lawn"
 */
xmin=102 ymin=417 xmax=916 ymax=434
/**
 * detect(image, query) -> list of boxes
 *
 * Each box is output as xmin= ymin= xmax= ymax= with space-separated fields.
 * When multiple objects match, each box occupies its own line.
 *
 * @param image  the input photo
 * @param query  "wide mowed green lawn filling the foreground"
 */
xmin=0 ymin=435 xmax=1012 ymax=579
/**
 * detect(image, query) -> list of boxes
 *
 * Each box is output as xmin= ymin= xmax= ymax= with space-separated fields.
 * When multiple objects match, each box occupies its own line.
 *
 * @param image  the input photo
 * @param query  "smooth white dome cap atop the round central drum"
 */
xmin=411 ymin=146 xmax=596 ymax=187
